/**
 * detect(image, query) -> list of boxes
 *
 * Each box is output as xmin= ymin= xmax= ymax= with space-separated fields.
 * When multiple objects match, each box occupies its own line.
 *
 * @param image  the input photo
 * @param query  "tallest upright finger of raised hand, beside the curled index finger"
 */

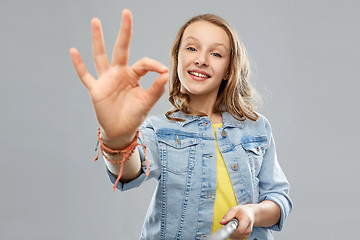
xmin=112 ymin=9 xmax=132 ymax=66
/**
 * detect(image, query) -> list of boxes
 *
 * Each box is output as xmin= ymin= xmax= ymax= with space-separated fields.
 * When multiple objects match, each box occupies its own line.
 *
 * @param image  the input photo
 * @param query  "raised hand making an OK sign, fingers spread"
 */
xmin=70 ymin=9 xmax=169 ymax=148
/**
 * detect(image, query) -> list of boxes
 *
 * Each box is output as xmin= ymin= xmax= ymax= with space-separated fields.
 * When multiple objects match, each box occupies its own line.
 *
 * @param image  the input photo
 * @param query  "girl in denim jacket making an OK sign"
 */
xmin=70 ymin=10 xmax=292 ymax=240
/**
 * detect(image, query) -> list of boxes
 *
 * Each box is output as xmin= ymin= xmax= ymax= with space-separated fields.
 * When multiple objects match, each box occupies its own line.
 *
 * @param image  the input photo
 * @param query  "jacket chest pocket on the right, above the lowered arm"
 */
xmin=241 ymin=137 xmax=267 ymax=177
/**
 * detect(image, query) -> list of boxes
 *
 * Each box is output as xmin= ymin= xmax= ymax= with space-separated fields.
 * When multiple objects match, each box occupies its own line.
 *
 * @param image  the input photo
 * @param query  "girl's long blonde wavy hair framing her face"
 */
xmin=165 ymin=14 xmax=259 ymax=121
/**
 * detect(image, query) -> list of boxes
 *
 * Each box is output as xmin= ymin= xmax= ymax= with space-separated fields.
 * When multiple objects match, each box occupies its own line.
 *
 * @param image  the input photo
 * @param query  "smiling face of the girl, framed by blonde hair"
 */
xmin=177 ymin=21 xmax=230 ymax=101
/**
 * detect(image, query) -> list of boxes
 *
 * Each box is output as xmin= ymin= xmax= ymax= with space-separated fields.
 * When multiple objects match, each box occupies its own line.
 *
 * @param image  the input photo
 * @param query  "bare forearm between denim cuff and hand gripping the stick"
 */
xmin=247 ymin=200 xmax=281 ymax=227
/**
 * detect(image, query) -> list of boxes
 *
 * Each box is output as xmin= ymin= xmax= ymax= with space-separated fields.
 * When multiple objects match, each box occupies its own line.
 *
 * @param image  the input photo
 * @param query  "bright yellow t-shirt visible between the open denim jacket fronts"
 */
xmin=211 ymin=123 xmax=237 ymax=233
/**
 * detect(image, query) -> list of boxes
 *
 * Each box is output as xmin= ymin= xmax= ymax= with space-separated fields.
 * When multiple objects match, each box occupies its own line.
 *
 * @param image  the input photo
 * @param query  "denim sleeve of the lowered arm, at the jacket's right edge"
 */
xmin=258 ymin=119 xmax=292 ymax=231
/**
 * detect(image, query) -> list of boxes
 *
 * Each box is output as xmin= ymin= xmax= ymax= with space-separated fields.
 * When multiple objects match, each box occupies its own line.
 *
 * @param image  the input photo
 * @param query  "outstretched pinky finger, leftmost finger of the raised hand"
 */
xmin=70 ymin=48 xmax=95 ymax=90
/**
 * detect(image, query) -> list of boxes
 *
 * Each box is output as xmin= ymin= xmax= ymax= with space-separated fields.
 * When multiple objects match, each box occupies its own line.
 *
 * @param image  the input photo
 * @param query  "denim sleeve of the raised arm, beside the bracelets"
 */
xmin=106 ymin=119 xmax=160 ymax=191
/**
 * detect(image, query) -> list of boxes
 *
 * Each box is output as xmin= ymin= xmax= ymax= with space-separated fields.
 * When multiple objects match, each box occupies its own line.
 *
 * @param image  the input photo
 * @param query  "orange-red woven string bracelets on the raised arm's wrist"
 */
xmin=94 ymin=128 xmax=149 ymax=191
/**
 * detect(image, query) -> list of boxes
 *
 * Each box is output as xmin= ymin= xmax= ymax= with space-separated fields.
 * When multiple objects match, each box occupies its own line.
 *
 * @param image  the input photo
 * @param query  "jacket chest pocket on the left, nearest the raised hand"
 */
xmin=158 ymin=134 xmax=198 ymax=174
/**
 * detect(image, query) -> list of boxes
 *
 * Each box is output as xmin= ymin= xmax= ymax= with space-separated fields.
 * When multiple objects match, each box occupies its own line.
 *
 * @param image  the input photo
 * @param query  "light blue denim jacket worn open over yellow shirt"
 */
xmin=108 ymin=112 xmax=292 ymax=240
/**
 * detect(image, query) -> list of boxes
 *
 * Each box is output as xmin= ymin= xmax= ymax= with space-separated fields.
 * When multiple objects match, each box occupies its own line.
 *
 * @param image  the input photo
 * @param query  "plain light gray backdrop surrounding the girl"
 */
xmin=0 ymin=0 xmax=360 ymax=239
